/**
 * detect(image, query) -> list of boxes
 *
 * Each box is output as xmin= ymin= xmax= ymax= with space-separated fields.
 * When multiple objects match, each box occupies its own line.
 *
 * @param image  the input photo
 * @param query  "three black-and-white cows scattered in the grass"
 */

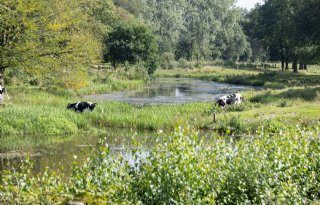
xmin=0 ymin=85 xmax=243 ymax=112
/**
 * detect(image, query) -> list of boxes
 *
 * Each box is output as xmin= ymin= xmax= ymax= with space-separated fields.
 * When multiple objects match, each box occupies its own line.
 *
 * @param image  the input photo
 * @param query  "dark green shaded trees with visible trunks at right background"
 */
xmin=243 ymin=0 xmax=320 ymax=72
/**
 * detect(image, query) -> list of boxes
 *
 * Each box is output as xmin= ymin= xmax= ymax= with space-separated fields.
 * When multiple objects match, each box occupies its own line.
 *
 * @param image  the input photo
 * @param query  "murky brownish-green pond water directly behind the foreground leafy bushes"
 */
xmin=0 ymin=128 xmax=218 ymax=174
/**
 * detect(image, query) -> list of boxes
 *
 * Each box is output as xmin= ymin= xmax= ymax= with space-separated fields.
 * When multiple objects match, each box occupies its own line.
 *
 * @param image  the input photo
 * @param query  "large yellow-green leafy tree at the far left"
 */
xmin=0 ymin=0 xmax=106 ymax=89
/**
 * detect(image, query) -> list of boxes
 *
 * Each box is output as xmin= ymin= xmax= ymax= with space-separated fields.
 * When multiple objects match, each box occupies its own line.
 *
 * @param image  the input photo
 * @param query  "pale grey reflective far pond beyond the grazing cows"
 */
xmin=84 ymin=78 xmax=253 ymax=104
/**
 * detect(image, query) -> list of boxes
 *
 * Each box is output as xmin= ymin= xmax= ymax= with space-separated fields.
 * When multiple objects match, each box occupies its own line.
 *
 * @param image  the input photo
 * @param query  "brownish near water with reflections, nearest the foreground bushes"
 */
xmin=0 ymin=129 xmax=153 ymax=173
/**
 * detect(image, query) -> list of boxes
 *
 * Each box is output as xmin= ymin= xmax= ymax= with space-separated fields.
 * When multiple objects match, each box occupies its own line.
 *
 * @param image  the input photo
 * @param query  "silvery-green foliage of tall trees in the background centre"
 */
xmin=142 ymin=0 xmax=250 ymax=61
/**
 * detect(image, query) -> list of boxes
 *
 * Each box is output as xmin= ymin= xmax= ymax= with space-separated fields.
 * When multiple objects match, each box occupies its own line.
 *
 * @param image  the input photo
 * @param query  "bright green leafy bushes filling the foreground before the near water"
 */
xmin=0 ymin=126 xmax=320 ymax=204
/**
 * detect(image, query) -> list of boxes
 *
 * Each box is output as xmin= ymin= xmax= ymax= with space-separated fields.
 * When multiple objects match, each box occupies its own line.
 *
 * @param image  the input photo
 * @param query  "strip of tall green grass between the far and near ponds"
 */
xmin=0 ymin=85 xmax=319 ymax=135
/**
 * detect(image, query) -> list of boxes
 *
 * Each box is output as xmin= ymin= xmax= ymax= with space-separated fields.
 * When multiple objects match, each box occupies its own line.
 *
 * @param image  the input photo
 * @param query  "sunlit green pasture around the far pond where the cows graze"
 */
xmin=0 ymin=65 xmax=320 ymax=135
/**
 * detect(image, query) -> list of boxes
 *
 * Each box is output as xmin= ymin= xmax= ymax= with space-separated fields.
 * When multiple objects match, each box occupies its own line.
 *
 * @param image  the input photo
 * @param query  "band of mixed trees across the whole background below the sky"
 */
xmin=0 ymin=0 xmax=320 ymax=89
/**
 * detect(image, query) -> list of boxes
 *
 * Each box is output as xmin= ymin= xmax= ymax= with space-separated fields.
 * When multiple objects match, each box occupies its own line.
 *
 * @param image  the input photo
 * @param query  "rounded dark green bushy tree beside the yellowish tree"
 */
xmin=104 ymin=22 xmax=158 ymax=74
